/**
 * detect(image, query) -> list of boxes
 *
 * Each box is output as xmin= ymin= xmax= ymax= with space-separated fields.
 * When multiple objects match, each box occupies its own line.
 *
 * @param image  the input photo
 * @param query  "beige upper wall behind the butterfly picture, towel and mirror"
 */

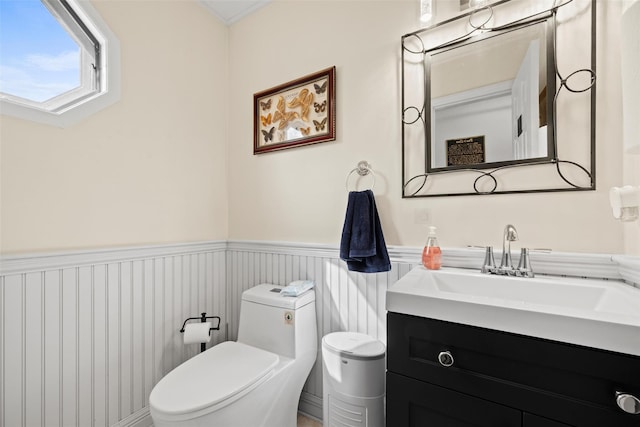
xmin=229 ymin=1 xmax=624 ymax=253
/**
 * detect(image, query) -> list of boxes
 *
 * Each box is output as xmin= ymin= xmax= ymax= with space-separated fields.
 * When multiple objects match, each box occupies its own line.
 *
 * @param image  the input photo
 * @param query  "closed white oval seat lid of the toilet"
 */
xmin=149 ymin=341 xmax=280 ymax=419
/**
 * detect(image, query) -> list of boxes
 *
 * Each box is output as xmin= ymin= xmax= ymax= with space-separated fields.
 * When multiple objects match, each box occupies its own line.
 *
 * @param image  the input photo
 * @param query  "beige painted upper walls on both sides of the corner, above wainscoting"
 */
xmin=0 ymin=0 xmax=639 ymax=254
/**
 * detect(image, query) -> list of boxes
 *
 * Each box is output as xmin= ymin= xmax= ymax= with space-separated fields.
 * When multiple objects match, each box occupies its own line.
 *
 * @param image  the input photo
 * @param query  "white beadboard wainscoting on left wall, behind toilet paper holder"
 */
xmin=0 ymin=242 xmax=227 ymax=427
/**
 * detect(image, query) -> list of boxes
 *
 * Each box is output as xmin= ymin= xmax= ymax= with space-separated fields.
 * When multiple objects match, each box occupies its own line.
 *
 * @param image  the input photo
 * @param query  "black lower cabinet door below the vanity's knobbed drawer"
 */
xmin=387 ymin=372 xmax=522 ymax=427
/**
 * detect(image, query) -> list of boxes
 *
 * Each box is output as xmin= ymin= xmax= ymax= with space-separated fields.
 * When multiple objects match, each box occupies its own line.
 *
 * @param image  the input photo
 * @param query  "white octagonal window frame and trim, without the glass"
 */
xmin=0 ymin=0 xmax=120 ymax=127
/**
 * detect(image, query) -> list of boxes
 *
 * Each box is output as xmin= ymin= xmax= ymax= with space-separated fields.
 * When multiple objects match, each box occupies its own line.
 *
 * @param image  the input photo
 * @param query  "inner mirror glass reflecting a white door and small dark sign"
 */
xmin=425 ymin=20 xmax=555 ymax=172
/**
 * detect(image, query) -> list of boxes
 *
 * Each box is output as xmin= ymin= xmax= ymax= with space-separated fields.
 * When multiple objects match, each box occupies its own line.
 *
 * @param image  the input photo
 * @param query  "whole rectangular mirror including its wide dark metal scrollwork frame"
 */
xmin=402 ymin=0 xmax=595 ymax=197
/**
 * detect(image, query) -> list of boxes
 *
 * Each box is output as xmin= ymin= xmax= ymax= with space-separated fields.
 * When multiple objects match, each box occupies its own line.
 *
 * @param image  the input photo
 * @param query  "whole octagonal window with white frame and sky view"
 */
xmin=0 ymin=0 xmax=119 ymax=126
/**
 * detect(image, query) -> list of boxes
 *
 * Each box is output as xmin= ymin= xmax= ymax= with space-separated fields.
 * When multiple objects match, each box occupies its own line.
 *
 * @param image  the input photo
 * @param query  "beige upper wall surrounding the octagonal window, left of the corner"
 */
xmin=0 ymin=1 xmax=228 ymax=254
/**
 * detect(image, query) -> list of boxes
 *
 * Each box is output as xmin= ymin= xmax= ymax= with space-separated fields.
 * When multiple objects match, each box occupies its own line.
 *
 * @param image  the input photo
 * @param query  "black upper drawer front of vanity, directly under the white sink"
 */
xmin=387 ymin=313 xmax=640 ymax=427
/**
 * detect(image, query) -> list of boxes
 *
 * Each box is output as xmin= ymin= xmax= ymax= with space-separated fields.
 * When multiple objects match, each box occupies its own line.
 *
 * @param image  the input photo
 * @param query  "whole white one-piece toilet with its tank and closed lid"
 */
xmin=149 ymin=284 xmax=318 ymax=427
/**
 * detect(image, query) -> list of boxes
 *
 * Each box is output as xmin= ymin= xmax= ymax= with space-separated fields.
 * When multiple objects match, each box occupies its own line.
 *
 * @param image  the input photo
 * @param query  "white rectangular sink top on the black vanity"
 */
xmin=386 ymin=267 xmax=640 ymax=356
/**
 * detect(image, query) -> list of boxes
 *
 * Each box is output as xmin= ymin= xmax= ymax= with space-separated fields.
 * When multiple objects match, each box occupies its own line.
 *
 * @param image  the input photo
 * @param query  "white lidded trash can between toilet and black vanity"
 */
xmin=322 ymin=332 xmax=385 ymax=427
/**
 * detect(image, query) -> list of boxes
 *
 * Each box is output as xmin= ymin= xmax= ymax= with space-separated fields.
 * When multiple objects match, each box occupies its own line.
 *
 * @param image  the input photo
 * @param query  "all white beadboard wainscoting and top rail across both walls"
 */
xmin=0 ymin=241 xmax=640 ymax=427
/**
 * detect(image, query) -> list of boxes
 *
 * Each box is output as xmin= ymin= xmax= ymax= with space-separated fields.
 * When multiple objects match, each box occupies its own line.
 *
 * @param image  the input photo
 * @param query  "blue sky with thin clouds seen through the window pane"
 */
xmin=0 ymin=0 xmax=80 ymax=102
